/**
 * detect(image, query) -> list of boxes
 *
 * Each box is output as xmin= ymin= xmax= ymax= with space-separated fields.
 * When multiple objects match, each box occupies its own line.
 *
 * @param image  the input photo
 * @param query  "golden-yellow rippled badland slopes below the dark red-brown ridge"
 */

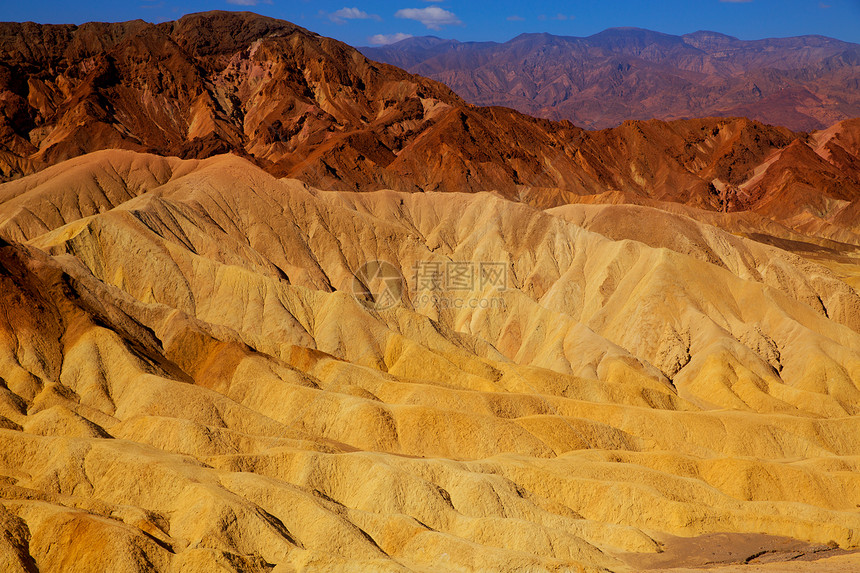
xmin=0 ymin=152 xmax=860 ymax=571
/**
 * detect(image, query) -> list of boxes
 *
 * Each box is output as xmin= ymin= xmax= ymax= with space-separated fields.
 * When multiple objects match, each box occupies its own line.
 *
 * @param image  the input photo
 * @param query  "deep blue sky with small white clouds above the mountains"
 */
xmin=0 ymin=0 xmax=860 ymax=46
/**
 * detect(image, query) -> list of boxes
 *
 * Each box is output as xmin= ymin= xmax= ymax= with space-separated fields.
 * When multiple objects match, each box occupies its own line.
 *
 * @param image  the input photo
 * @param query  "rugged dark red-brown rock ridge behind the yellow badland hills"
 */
xmin=0 ymin=12 xmax=860 ymax=239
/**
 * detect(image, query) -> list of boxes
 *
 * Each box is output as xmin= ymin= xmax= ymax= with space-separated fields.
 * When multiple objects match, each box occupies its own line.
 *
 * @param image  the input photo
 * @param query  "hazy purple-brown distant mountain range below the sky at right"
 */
xmin=361 ymin=28 xmax=860 ymax=130
